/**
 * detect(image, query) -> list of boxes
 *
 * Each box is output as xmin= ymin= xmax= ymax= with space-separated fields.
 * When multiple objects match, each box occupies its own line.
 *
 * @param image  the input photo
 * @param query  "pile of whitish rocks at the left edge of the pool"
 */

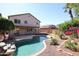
xmin=0 ymin=39 xmax=16 ymax=55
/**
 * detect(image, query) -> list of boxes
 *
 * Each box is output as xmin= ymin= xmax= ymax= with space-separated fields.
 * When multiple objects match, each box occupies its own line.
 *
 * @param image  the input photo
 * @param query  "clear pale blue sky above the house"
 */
xmin=0 ymin=3 xmax=70 ymax=25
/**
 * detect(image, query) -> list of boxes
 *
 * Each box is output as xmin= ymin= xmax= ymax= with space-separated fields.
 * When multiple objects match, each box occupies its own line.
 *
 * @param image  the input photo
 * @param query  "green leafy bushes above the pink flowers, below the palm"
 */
xmin=58 ymin=18 xmax=79 ymax=31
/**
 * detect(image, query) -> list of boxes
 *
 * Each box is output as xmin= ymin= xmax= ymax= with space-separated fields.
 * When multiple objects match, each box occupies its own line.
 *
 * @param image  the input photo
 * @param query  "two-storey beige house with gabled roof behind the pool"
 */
xmin=8 ymin=13 xmax=40 ymax=34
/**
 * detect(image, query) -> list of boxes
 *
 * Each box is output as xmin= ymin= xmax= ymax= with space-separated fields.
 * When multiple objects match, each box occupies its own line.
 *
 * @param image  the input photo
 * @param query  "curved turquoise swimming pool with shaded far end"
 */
xmin=16 ymin=36 xmax=46 ymax=56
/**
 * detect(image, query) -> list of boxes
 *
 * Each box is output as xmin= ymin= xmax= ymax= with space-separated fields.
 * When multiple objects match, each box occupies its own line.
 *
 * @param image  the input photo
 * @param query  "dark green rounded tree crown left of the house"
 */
xmin=0 ymin=17 xmax=15 ymax=34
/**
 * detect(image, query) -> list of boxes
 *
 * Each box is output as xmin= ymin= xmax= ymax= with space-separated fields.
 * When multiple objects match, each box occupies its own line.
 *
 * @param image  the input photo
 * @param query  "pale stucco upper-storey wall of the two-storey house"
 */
xmin=9 ymin=13 xmax=40 ymax=27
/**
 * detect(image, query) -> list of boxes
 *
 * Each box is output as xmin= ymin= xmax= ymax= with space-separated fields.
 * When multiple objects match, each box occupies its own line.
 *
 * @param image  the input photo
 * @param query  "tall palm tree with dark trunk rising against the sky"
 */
xmin=65 ymin=3 xmax=79 ymax=20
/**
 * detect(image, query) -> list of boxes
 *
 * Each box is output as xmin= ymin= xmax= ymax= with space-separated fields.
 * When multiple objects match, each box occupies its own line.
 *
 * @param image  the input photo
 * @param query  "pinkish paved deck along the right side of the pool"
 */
xmin=38 ymin=40 xmax=79 ymax=56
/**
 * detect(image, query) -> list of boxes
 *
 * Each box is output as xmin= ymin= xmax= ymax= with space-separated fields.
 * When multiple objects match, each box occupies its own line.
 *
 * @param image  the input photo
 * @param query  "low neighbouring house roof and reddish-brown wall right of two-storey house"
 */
xmin=40 ymin=25 xmax=57 ymax=34
